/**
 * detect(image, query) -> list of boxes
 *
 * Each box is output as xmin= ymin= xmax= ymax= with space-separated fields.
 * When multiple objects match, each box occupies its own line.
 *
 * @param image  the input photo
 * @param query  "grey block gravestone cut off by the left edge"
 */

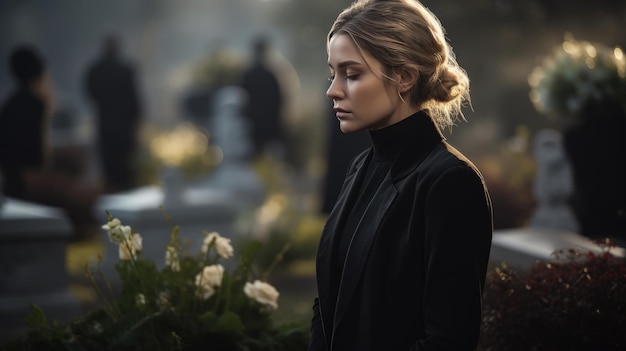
xmin=0 ymin=198 xmax=82 ymax=339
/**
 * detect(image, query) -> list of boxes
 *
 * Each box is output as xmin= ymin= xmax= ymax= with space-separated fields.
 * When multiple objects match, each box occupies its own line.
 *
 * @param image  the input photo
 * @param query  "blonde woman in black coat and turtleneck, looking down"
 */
xmin=309 ymin=0 xmax=492 ymax=351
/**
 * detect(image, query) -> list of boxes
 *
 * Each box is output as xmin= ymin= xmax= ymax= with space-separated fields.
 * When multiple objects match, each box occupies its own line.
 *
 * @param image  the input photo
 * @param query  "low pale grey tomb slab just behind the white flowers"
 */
xmin=96 ymin=186 xmax=239 ymax=277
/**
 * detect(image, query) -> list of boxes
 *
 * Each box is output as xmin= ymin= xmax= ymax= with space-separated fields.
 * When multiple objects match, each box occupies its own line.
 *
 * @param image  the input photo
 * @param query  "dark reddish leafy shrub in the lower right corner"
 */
xmin=478 ymin=241 xmax=626 ymax=351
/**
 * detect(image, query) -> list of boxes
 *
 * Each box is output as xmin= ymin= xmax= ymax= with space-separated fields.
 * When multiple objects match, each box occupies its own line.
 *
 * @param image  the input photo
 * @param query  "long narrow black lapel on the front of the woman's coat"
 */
xmin=333 ymin=173 xmax=398 ymax=340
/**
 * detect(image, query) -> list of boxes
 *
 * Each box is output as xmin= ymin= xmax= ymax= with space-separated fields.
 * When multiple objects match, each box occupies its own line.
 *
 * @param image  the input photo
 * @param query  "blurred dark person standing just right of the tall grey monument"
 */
xmin=241 ymin=38 xmax=284 ymax=156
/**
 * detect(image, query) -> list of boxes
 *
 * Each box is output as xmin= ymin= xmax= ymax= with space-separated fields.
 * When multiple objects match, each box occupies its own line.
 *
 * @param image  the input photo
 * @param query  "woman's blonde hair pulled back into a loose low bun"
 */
xmin=327 ymin=0 xmax=470 ymax=128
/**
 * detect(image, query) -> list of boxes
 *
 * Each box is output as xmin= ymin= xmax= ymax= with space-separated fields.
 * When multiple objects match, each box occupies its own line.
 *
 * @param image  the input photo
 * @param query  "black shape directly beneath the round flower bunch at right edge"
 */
xmin=564 ymin=102 xmax=626 ymax=245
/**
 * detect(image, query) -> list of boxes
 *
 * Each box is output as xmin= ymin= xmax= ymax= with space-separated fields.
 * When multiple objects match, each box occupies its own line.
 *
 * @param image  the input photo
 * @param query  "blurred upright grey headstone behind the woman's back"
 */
xmin=530 ymin=129 xmax=580 ymax=233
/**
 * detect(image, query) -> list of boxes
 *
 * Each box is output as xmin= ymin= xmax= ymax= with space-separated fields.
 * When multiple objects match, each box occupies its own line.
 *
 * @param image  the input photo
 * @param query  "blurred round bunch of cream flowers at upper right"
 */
xmin=528 ymin=33 xmax=626 ymax=122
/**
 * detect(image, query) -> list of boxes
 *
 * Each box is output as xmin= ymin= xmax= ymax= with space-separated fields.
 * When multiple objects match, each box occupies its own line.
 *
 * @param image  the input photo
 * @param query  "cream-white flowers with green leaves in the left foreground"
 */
xmin=7 ymin=213 xmax=309 ymax=351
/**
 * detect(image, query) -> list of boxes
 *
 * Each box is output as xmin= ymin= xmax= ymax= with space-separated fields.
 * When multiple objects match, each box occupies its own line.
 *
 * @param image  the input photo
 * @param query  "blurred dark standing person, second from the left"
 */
xmin=85 ymin=36 xmax=141 ymax=192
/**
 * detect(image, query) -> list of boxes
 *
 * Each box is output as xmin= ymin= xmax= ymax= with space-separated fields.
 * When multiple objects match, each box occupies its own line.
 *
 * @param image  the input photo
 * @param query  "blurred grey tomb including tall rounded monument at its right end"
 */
xmin=95 ymin=87 xmax=265 ymax=276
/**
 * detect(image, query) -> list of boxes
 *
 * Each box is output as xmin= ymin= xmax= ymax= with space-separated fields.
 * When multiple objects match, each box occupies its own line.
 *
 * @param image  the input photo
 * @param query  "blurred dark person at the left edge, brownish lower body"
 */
xmin=0 ymin=44 xmax=98 ymax=235
